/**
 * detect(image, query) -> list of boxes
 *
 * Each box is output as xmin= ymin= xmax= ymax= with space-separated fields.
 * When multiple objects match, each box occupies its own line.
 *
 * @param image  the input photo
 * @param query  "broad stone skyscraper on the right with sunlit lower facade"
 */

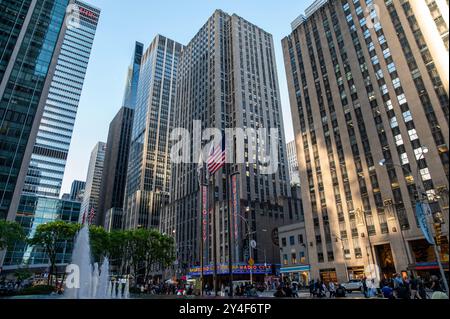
xmin=283 ymin=0 xmax=449 ymax=282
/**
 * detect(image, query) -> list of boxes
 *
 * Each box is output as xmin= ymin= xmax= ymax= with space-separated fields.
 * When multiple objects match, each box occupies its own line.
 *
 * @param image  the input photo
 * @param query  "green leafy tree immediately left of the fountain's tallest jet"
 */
xmin=29 ymin=221 xmax=80 ymax=286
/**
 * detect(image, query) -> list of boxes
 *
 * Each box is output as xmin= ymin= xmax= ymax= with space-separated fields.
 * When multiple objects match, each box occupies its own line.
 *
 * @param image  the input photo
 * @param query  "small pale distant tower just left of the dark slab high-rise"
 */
xmin=80 ymin=142 xmax=106 ymax=223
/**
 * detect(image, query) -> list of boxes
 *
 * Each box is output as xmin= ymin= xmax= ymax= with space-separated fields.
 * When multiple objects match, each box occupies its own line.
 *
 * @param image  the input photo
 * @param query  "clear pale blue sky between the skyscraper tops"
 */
xmin=62 ymin=0 xmax=312 ymax=193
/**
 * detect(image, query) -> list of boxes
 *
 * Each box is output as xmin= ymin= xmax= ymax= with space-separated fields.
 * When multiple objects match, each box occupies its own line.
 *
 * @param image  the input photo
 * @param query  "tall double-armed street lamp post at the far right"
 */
xmin=379 ymin=146 xmax=449 ymax=294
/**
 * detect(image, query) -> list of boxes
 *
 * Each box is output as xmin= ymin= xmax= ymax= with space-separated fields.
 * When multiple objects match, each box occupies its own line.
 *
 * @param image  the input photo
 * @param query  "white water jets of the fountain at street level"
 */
xmin=64 ymin=226 xmax=130 ymax=299
